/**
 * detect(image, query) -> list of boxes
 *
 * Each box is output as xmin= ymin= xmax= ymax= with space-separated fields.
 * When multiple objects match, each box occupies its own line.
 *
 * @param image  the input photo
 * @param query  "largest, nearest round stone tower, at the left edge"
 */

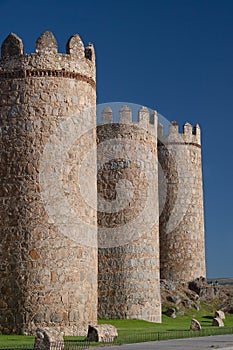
xmin=0 ymin=32 xmax=97 ymax=335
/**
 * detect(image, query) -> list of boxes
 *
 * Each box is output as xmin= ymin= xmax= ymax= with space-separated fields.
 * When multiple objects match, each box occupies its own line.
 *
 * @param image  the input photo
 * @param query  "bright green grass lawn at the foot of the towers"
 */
xmin=0 ymin=305 xmax=233 ymax=347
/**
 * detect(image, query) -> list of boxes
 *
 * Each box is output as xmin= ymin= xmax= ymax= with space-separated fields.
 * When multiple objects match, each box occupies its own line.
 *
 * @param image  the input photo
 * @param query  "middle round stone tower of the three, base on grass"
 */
xmin=97 ymin=106 xmax=161 ymax=322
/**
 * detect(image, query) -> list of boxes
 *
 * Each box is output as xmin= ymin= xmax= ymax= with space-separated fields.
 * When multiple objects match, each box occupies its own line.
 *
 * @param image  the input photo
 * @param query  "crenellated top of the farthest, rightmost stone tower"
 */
xmin=158 ymin=121 xmax=201 ymax=146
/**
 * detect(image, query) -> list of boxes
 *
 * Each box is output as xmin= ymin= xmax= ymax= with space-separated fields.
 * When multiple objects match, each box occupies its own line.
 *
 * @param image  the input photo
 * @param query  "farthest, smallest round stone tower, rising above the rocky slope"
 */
xmin=158 ymin=122 xmax=206 ymax=281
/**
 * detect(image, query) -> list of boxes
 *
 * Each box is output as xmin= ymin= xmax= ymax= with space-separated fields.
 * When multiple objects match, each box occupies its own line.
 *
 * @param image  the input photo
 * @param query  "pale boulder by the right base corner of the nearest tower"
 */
xmin=87 ymin=324 xmax=118 ymax=343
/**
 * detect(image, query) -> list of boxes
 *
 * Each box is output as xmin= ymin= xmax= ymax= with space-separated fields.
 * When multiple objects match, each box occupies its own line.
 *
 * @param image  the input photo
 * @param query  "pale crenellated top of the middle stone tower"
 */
xmin=100 ymin=105 xmax=158 ymax=135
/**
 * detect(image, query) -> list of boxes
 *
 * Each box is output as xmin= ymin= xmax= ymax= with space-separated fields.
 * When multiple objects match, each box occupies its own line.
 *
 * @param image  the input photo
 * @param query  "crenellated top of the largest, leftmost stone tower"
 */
xmin=0 ymin=32 xmax=96 ymax=87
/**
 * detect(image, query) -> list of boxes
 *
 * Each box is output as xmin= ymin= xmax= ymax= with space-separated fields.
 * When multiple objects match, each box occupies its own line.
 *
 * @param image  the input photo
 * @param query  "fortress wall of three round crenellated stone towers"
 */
xmin=0 ymin=32 xmax=205 ymax=335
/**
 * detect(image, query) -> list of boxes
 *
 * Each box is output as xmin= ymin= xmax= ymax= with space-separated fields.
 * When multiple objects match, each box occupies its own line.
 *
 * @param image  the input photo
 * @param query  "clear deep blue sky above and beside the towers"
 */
xmin=0 ymin=0 xmax=233 ymax=277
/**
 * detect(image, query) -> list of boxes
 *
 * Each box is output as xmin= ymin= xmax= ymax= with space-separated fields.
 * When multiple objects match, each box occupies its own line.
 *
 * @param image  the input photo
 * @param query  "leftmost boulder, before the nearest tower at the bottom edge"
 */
xmin=34 ymin=327 xmax=64 ymax=350
